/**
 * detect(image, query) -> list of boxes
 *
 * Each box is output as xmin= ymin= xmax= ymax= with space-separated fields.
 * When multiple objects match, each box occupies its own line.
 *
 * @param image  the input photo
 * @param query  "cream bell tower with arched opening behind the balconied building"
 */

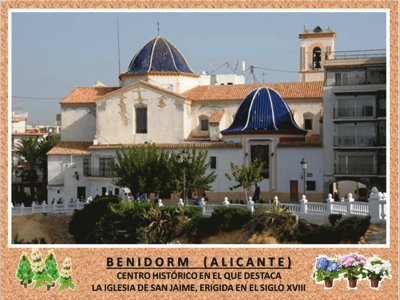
xmin=299 ymin=26 xmax=336 ymax=82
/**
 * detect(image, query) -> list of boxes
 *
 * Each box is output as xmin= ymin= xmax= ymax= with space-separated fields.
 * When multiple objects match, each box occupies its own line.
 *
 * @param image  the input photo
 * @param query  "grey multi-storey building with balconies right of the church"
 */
xmin=323 ymin=50 xmax=386 ymax=200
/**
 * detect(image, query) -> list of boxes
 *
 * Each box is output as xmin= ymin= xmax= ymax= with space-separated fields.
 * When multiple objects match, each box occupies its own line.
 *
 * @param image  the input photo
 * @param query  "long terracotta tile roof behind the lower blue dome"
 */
xmin=183 ymin=81 xmax=323 ymax=101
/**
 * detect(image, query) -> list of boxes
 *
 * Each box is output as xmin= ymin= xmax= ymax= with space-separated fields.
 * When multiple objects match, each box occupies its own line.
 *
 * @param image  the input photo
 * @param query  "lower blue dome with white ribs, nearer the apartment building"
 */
xmin=222 ymin=87 xmax=307 ymax=134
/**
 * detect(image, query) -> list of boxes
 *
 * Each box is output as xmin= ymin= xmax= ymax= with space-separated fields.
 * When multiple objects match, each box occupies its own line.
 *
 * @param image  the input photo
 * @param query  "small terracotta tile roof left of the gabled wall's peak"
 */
xmin=60 ymin=87 xmax=119 ymax=105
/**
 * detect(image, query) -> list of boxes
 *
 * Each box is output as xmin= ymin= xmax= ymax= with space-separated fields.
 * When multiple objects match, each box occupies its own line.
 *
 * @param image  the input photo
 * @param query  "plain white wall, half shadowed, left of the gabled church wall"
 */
xmin=61 ymin=106 xmax=96 ymax=141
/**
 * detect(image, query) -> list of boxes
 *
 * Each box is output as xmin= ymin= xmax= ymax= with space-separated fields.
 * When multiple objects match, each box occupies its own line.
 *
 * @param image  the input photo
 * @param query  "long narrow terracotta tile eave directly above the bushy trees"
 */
xmin=88 ymin=142 xmax=242 ymax=151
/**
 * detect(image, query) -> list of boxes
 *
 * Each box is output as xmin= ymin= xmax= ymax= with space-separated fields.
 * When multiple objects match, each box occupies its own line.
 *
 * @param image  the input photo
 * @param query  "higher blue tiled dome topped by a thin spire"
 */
xmin=127 ymin=36 xmax=193 ymax=74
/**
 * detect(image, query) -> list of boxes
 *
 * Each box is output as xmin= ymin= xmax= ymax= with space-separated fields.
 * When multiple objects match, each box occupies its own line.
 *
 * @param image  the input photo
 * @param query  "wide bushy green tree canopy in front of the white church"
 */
xmin=113 ymin=144 xmax=216 ymax=195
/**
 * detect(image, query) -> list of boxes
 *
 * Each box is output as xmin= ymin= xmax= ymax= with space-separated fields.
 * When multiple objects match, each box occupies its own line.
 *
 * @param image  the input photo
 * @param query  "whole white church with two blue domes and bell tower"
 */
xmin=48 ymin=26 xmax=335 ymax=202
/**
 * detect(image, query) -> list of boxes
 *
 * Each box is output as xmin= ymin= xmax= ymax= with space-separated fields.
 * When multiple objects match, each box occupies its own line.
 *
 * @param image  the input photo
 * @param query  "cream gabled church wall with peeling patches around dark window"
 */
xmin=97 ymin=86 xmax=185 ymax=144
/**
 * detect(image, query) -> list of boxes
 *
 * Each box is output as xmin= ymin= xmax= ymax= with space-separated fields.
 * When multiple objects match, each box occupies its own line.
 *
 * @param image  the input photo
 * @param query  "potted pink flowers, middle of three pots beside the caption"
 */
xmin=338 ymin=253 xmax=367 ymax=288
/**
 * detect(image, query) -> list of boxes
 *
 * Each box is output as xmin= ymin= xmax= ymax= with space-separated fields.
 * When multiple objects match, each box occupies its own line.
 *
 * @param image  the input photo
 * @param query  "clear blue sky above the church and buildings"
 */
xmin=12 ymin=11 xmax=386 ymax=125
